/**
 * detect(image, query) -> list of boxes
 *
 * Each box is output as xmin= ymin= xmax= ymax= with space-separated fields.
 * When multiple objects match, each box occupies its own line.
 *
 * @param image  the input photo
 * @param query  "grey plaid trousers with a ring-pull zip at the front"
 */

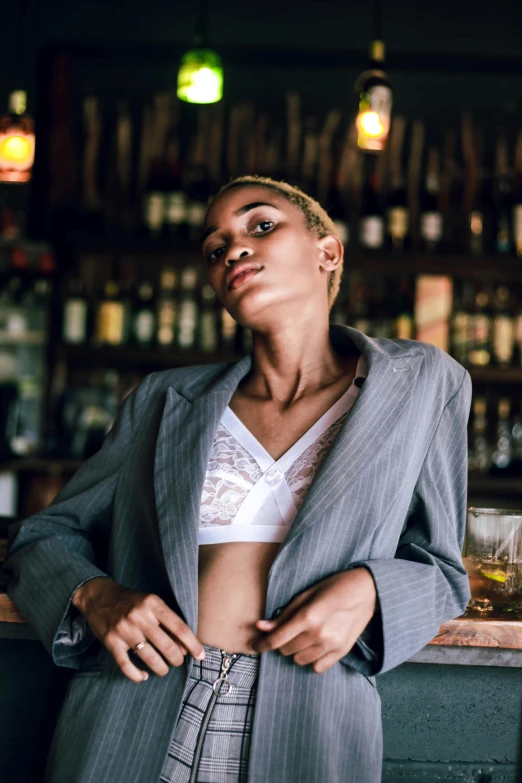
xmin=160 ymin=644 xmax=259 ymax=783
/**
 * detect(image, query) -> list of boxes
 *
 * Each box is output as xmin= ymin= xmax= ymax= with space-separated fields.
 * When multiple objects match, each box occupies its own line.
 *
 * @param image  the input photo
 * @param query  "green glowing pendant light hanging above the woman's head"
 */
xmin=177 ymin=0 xmax=223 ymax=103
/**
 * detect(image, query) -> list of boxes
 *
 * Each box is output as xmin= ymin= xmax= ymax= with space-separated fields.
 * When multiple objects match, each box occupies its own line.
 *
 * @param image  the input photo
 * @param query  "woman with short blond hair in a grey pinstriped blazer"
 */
xmin=5 ymin=177 xmax=471 ymax=783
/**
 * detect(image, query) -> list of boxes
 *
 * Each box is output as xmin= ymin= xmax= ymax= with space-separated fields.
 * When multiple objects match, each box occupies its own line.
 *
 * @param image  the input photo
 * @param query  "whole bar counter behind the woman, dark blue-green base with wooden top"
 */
xmin=0 ymin=593 xmax=522 ymax=783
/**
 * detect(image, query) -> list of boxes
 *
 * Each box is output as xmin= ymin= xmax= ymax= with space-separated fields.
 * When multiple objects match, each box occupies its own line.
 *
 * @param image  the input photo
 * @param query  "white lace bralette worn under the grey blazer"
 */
xmin=199 ymin=355 xmax=367 ymax=544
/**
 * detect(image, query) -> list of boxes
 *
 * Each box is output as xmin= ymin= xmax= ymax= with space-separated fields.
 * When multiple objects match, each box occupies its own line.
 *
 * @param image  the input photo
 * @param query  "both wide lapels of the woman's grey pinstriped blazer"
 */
xmin=154 ymin=324 xmax=422 ymax=631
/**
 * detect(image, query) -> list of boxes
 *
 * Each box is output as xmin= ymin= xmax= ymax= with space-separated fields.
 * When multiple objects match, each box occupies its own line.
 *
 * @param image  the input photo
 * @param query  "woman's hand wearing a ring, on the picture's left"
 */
xmin=72 ymin=577 xmax=204 ymax=682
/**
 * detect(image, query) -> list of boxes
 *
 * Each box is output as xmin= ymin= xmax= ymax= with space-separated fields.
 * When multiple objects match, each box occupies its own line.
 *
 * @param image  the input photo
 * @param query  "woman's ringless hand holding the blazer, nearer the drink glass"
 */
xmin=253 ymin=568 xmax=377 ymax=674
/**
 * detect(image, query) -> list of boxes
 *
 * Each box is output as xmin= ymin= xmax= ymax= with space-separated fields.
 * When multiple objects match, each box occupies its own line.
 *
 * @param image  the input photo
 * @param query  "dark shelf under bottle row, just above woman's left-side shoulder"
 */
xmin=56 ymin=343 xmax=243 ymax=369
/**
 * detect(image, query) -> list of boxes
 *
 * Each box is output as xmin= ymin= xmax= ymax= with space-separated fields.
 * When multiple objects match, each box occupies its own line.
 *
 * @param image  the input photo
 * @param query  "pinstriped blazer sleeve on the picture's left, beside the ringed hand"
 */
xmin=2 ymin=375 xmax=152 ymax=669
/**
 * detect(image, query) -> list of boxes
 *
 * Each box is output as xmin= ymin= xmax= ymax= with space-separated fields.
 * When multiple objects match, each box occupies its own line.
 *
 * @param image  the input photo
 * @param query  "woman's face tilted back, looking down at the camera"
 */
xmin=199 ymin=185 xmax=342 ymax=328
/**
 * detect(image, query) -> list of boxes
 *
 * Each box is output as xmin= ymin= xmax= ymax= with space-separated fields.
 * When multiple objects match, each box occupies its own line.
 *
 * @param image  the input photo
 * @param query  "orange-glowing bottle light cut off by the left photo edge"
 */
xmin=0 ymin=90 xmax=35 ymax=182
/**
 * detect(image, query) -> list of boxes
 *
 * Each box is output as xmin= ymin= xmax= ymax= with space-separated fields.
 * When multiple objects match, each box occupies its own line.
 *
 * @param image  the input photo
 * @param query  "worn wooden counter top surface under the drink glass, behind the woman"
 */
xmin=0 ymin=593 xmax=522 ymax=650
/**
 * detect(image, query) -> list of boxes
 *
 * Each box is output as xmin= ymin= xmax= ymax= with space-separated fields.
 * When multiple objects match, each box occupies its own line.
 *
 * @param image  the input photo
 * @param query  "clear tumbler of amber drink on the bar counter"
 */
xmin=463 ymin=508 xmax=522 ymax=616
